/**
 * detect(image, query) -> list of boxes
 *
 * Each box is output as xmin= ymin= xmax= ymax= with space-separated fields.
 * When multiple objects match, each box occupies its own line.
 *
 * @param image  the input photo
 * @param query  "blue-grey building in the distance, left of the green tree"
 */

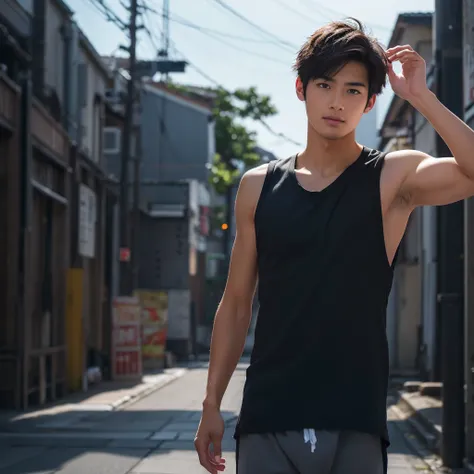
xmin=106 ymin=78 xmax=215 ymax=358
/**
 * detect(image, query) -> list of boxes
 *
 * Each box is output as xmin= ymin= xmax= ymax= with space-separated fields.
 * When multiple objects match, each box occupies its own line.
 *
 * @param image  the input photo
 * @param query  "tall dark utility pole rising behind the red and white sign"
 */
xmin=120 ymin=0 xmax=138 ymax=296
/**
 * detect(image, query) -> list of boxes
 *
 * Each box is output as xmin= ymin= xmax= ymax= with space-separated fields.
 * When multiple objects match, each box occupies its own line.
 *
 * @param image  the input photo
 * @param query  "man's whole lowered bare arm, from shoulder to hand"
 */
xmin=195 ymin=165 xmax=267 ymax=472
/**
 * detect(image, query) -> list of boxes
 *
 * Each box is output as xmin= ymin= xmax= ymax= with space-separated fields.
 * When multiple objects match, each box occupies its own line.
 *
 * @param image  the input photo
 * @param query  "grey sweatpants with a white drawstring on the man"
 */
xmin=237 ymin=430 xmax=384 ymax=474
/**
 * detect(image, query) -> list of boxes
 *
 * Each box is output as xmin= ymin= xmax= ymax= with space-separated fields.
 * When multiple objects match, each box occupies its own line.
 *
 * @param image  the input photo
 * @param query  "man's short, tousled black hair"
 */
xmin=293 ymin=18 xmax=388 ymax=98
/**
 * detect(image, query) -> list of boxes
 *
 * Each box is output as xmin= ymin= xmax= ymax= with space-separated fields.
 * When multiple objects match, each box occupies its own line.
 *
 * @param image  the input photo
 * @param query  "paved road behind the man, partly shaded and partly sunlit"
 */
xmin=0 ymin=364 xmax=434 ymax=474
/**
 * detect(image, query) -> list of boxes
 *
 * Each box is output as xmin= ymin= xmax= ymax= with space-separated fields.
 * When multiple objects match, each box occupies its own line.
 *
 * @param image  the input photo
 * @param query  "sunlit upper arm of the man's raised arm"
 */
xmin=401 ymin=153 xmax=474 ymax=206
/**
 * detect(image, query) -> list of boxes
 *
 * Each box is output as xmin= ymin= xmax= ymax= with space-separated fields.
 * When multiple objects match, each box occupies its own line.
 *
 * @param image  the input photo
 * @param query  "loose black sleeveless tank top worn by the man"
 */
xmin=235 ymin=148 xmax=393 ymax=472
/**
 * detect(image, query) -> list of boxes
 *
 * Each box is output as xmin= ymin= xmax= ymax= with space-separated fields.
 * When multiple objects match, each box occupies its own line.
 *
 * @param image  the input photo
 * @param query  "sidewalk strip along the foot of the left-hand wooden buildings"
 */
xmin=0 ymin=367 xmax=188 ymax=432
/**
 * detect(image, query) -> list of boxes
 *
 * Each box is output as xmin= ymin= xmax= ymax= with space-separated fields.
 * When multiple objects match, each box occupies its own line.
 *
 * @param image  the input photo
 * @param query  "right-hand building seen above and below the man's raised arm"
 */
xmin=378 ymin=13 xmax=437 ymax=378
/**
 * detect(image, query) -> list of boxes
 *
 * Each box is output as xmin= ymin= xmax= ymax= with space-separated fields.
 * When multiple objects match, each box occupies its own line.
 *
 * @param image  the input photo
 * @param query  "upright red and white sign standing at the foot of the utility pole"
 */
xmin=112 ymin=297 xmax=143 ymax=380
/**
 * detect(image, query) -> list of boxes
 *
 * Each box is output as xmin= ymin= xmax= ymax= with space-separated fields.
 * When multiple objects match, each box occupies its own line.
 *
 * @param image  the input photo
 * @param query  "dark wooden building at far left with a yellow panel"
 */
xmin=0 ymin=0 xmax=121 ymax=409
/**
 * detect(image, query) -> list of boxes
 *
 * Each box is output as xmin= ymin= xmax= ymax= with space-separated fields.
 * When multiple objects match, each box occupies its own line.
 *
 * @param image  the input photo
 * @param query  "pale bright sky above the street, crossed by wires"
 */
xmin=65 ymin=0 xmax=434 ymax=157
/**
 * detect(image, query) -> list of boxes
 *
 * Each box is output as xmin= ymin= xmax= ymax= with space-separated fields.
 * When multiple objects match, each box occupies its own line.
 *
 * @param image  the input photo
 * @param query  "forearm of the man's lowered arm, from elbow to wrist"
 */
xmin=204 ymin=303 xmax=251 ymax=408
